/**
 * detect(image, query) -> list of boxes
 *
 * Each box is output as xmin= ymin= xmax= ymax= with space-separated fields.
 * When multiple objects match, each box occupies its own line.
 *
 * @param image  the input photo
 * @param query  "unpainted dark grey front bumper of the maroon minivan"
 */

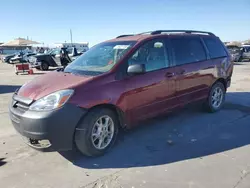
xmin=9 ymin=95 xmax=86 ymax=151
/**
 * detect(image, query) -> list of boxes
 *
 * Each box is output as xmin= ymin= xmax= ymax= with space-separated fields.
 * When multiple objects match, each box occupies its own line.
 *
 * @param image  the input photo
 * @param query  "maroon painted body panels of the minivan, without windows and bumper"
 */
xmin=18 ymin=35 xmax=233 ymax=127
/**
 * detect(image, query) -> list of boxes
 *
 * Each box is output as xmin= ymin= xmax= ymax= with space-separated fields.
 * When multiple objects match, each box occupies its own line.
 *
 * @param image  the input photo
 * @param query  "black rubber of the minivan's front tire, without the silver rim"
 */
xmin=75 ymin=109 xmax=119 ymax=156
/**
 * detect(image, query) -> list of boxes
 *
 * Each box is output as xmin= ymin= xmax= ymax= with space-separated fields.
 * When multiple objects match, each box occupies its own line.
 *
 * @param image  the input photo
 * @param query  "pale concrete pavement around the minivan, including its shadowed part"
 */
xmin=0 ymin=62 xmax=250 ymax=188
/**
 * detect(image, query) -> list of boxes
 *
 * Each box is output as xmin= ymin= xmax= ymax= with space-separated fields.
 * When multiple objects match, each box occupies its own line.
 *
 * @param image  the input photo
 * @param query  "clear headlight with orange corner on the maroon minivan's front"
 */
xmin=29 ymin=89 xmax=74 ymax=111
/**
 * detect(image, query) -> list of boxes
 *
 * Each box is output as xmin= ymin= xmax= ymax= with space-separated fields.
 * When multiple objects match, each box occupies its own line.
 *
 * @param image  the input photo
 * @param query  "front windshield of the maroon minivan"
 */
xmin=64 ymin=41 xmax=136 ymax=75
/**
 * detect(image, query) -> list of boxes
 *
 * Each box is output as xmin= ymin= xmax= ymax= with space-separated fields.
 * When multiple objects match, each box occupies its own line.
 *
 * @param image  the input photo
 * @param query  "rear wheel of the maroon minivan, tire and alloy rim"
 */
xmin=205 ymin=82 xmax=226 ymax=113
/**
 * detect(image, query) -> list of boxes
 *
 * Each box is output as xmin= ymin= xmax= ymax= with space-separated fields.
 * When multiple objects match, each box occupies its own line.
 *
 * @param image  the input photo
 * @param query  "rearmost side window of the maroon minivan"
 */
xmin=203 ymin=37 xmax=227 ymax=58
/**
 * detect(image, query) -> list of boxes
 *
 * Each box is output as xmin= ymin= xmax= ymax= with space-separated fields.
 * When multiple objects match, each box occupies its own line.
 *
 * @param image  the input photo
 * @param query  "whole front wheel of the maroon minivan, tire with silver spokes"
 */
xmin=74 ymin=108 xmax=119 ymax=157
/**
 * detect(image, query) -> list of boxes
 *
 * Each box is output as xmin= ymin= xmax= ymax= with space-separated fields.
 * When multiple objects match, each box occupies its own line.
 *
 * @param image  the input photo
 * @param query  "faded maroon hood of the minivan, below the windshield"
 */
xmin=18 ymin=71 xmax=93 ymax=100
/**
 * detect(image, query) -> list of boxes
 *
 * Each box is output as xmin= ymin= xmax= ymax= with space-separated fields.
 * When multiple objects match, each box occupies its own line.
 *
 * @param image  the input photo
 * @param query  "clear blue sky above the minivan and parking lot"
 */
xmin=0 ymin=0 xmax=250 ymax=46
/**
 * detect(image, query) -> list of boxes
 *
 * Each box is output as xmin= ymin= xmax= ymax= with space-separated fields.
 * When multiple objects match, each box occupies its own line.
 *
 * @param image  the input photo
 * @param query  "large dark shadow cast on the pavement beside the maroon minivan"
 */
xmin=60 ymin=92 xmax=250 ymax=169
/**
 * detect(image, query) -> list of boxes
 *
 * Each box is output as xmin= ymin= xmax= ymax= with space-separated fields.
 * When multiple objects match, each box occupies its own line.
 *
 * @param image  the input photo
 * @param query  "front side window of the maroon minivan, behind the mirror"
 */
xmin=128 ymin=39 xmax=169 ymax=72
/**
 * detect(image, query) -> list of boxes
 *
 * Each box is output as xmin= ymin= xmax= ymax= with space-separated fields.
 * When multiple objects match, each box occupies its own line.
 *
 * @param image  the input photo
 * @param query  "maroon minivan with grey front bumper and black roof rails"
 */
xmin=9 ymin=30 xmax=233 ymax=156
